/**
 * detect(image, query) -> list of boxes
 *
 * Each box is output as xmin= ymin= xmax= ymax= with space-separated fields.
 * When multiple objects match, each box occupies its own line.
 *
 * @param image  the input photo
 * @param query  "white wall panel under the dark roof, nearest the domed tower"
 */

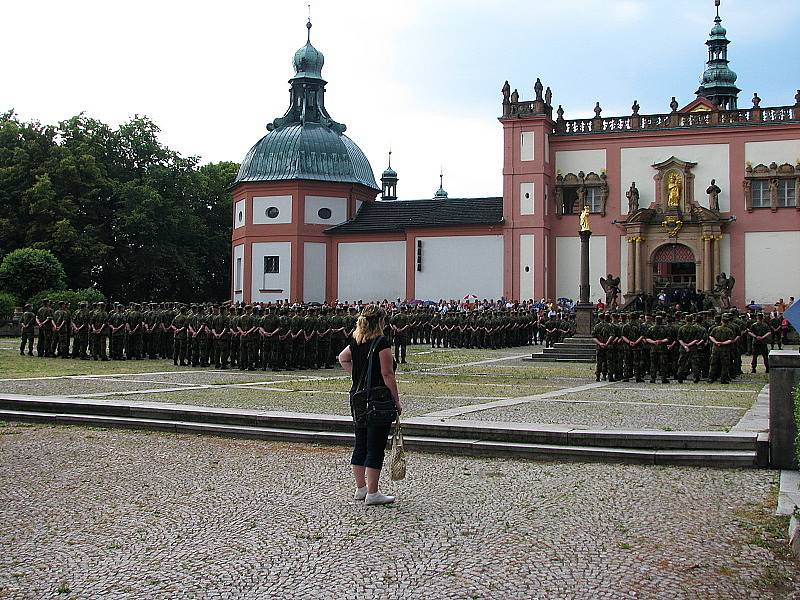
xmin=338 ymin=242 xmax=406 ymax=302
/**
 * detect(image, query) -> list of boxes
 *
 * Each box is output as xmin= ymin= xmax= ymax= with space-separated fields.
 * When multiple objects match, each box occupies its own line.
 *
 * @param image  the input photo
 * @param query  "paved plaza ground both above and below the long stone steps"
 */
xmin=0 ymin=340 xmax=800 ymax=599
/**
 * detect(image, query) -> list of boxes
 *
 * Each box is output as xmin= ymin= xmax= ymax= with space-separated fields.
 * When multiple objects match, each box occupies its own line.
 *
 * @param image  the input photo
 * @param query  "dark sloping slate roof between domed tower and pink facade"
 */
xmin=325 ymin=198 xmax=503 ymax=234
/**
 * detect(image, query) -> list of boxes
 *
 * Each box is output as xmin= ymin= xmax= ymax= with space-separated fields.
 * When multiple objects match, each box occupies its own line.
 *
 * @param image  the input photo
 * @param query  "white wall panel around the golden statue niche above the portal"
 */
xmin=619 ymin=144 xmax=741 ymax=214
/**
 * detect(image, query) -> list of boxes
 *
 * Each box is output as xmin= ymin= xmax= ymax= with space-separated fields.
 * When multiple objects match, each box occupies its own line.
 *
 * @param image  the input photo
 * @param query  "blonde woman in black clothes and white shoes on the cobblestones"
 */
xmin=339 ymin=305 xmax=403 ymax=505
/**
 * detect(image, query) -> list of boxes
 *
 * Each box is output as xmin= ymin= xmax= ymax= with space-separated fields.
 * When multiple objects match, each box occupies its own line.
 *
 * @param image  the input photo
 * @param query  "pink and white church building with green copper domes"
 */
xmin=232 ymin=9 xmax=800 ymax=306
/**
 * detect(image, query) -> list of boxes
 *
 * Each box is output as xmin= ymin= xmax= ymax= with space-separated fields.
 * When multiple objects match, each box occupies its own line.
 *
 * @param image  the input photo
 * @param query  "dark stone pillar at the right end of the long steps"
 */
xmin=769 ymin=350 xmax=800 ymax=469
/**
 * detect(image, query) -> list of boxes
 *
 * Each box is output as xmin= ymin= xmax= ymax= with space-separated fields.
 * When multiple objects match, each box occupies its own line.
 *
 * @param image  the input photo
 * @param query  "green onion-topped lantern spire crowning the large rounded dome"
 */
xmin=267 ymin=19 xmax=347 ymax=134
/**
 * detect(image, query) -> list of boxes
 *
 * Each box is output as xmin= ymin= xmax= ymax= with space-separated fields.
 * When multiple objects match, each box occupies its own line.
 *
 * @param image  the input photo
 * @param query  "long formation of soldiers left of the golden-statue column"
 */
xmin=20 ymin=301 xmax=574 ymax=370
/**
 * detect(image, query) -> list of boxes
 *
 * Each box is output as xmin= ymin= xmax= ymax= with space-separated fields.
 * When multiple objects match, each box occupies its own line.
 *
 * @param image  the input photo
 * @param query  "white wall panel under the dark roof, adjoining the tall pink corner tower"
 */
xmin=414 ymin=235 xmax=503 ymax=301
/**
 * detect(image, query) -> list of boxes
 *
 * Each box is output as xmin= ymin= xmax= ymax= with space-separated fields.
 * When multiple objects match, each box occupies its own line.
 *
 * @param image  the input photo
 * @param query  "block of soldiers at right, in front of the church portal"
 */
xmin=592 ymin=309 xmax=774 ymax=383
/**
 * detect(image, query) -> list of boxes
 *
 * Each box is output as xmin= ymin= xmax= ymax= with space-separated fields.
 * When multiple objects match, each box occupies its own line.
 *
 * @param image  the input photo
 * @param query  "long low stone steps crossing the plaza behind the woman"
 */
xmin=0 ymin=395 xmax=768 ymax=467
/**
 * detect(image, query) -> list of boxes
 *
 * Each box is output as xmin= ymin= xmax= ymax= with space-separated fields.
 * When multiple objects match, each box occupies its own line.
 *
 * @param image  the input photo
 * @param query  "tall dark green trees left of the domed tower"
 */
xmin=0 ymin=110 xmax=239 ymax=302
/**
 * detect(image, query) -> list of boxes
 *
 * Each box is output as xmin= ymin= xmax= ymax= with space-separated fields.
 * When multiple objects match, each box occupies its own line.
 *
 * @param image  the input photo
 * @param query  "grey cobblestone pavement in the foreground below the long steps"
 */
xmin=0 ymin=424 xmax=800 ymax=600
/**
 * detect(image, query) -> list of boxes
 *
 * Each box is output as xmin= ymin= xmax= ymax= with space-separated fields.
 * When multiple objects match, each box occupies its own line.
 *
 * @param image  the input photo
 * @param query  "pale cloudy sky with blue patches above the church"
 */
xmin=0 ymin=0 xmax=800 ymax=199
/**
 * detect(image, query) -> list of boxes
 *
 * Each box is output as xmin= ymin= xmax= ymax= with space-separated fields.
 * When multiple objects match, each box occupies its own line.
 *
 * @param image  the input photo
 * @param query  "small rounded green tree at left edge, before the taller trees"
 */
xmin=0 ymin=248 xmax=67 ymax=299
